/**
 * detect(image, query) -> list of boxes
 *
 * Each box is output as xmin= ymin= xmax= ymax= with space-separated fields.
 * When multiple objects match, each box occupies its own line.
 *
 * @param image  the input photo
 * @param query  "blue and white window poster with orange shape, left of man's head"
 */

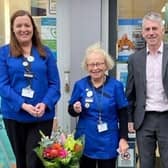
xmin=117 ymin=19 xmax=145 ymax=62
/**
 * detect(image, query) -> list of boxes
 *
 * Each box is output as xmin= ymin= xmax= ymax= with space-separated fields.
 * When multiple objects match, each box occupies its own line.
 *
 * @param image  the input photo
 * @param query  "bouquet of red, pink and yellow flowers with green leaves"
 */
xmin=35 ymin=129 xmax=84 ymax=168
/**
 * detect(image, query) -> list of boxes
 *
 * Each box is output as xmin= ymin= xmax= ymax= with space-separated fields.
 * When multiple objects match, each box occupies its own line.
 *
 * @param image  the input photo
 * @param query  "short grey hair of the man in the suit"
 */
xmin=142 ymin=11 xmax=164 ymax=28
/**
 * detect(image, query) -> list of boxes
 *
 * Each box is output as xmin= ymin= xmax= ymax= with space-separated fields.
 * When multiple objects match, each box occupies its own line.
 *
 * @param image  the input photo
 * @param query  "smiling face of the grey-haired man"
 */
xmin=142 ymin=20 xmax=164 ymax=48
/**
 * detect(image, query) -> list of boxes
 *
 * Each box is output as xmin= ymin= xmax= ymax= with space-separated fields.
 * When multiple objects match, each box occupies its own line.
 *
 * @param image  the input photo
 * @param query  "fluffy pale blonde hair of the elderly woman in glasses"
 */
xmin=82 ymin=43 xmax=115 ymax=71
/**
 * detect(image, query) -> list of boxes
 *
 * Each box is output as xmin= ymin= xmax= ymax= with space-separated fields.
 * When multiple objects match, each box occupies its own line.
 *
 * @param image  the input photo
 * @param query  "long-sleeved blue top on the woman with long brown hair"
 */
xmin=0 ymin=45 xmax=60 ymax=122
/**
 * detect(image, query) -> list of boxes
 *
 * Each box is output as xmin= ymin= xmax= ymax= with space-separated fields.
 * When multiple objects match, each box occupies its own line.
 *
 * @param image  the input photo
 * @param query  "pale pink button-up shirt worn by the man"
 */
xmin=145 ymin=43 xmax=168 ymax=112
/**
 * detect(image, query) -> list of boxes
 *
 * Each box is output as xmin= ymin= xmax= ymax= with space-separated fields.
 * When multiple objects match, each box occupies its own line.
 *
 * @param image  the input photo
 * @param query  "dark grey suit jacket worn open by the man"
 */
xmin=126 ymin=44 xmax=168 ymax=129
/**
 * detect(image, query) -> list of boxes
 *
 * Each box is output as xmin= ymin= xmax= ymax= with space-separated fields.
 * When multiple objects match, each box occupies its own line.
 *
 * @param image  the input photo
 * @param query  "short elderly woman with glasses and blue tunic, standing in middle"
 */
xmin=68 ymin=44 xmax=128 ymax=168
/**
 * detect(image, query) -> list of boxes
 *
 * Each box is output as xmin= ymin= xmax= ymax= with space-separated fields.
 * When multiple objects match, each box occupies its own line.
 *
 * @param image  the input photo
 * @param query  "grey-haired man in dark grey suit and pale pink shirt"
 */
xmin=126 ymin=12 xmax=168 ymax=168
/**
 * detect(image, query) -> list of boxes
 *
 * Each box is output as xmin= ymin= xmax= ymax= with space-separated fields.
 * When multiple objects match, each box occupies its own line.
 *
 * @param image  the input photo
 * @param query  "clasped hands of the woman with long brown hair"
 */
xmin=22 ymin=103 xmax=46 ymax=117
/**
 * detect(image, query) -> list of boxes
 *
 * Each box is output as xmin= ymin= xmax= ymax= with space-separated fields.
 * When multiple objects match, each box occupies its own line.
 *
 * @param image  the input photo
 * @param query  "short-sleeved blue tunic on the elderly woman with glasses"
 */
xmin=69 ymin=76 xmax=128 ymax=159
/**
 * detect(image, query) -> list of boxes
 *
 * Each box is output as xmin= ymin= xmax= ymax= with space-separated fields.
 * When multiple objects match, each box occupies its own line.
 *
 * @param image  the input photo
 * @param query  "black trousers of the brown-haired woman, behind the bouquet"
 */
xmin=4 ymin=119 xmax=53 ymax=168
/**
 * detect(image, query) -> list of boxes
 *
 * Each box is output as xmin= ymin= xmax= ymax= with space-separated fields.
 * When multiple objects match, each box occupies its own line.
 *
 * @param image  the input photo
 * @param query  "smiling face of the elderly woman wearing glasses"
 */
xmin=87 ymin=52 xmax=107 ymax=81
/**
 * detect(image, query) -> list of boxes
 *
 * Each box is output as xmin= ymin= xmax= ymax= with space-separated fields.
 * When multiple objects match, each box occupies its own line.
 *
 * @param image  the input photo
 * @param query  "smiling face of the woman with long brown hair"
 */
xmin=12 ymin=15 xmax=33 ymax=45
